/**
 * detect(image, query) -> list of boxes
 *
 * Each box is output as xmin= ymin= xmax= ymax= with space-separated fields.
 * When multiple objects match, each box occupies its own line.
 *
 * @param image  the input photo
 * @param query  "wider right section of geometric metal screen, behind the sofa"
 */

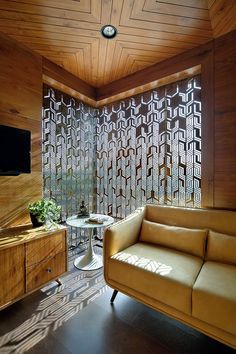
xmin=96 ymin=76 xmax=201 ymax=217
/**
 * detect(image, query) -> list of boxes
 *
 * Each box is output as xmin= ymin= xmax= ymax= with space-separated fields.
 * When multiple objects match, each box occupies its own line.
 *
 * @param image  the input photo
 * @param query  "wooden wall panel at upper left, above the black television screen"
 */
xmin=0 ymin=33 xmax=42 ymax=121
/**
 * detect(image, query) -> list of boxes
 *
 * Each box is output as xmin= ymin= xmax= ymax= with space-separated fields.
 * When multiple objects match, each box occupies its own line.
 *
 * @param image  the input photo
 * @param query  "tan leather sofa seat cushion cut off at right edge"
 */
xmin=192 ymin=261 xmax=236 ymax=335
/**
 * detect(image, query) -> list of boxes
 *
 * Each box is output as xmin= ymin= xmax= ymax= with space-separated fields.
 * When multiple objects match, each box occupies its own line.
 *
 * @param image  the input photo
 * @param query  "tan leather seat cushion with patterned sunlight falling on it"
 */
xmin=108 ymin=242 xmax=203 ymax=314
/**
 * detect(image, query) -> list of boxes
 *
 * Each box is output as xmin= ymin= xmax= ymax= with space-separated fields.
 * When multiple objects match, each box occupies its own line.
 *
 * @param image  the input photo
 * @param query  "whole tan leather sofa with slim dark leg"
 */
xmin=104 ymin=205 xmax=236 ymax=348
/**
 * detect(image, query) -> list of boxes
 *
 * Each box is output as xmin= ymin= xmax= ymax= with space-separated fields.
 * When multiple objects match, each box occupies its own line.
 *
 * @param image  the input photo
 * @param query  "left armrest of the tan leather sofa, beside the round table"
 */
xmin=103 ymin=207 xmax=146 ymax=279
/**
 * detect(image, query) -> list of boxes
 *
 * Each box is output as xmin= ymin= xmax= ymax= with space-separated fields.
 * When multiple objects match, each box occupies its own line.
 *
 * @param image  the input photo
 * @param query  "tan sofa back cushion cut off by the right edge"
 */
xmin=206 ymin=230 xmax=236 ymax=265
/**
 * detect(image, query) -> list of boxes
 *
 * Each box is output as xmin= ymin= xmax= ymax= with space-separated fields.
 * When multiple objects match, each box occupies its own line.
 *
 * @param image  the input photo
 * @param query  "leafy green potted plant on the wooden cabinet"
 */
xmin=28 ymin=198 xmax=61 ymax=227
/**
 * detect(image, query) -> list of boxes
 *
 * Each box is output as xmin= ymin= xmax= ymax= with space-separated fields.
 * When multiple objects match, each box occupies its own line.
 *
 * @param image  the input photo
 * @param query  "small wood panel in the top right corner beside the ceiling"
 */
xmin=208 ymin=0 xmax=236 ymax=38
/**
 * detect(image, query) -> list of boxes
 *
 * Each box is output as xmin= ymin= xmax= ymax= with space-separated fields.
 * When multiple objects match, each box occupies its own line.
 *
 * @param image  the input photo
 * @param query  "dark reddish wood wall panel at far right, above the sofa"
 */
xmin=214 ymin=31 xmax=236 ymax=209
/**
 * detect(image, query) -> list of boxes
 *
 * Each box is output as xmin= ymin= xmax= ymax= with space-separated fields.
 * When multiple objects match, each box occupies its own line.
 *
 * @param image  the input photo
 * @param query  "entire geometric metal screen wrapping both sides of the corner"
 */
xmin=43 ymin=76 xmax=201 ymax=230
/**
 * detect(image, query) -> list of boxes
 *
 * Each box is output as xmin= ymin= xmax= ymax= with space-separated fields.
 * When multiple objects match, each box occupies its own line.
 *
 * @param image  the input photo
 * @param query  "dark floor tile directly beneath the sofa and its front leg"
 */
xmin=95 ymin=290 xmax=235 ymax=354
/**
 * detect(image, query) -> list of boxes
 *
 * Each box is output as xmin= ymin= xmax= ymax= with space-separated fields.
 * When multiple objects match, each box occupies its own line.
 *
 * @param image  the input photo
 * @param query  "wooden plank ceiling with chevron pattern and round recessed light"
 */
xmin=0 ymin=0 xmax=236 ymax=87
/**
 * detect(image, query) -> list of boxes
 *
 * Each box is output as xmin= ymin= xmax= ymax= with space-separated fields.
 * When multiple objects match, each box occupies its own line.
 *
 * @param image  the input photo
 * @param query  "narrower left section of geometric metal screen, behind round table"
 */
xmin=43 ymin=85 xmax=96 ymax=246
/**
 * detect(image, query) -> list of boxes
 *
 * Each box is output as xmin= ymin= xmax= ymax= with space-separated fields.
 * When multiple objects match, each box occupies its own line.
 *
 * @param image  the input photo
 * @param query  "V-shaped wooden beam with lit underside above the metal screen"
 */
xmin=43 ymin=40 xmax=214 ymax=107
